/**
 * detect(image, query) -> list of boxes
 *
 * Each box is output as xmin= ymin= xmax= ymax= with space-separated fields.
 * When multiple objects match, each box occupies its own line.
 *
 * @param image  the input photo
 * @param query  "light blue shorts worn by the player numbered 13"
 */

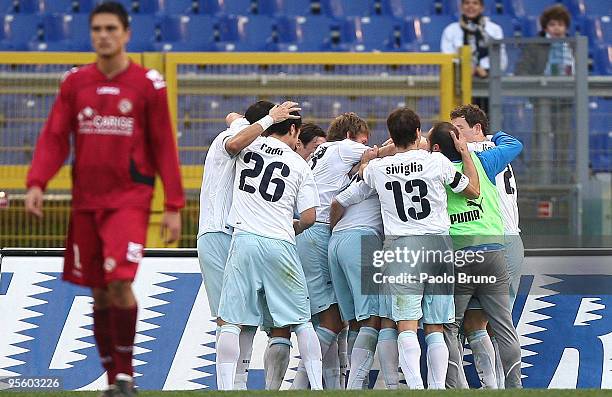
xmin=379 ymin=236 xmax=455 ymax=324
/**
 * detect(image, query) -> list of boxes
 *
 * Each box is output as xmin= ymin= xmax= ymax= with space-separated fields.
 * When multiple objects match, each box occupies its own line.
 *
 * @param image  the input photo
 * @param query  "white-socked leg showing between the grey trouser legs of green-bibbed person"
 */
xmin=463 ymin=310 xmax=503 ymax=389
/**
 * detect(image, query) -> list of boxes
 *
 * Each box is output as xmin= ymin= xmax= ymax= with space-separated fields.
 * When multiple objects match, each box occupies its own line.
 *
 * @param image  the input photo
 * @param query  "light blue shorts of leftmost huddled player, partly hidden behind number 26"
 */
xmin=198 ymin=232 xmax=232 ymax=317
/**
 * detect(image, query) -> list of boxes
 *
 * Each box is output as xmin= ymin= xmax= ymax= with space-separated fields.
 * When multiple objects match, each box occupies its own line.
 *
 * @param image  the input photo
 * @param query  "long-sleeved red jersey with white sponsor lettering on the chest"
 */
xmin=27 ymin=62 xmax=185 ymax=211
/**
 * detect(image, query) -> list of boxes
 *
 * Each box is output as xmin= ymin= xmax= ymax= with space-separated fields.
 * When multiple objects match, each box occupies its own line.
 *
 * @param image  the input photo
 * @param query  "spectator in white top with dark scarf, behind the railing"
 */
xmin=440 ymin=0 xmax=507 ymax=78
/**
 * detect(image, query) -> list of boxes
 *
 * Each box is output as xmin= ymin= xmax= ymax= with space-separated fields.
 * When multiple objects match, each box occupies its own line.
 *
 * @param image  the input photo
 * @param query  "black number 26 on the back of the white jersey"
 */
xmin=238 ymin=152 xmax=290 ymax=202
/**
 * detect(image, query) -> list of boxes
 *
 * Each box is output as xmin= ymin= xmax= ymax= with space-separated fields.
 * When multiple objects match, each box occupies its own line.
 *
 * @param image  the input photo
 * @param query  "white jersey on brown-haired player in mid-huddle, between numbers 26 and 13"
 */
xmin=309 ymin=139 xmax=368 ymax=223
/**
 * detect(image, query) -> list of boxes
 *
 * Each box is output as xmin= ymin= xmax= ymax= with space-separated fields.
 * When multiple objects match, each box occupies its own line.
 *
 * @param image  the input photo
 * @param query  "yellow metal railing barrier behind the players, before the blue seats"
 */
xmin=0 ymin=50 xmax=471 ymax=247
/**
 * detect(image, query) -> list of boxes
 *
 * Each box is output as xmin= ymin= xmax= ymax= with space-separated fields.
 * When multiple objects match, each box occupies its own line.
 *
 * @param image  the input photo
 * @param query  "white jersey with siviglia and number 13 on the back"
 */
xmin=363 ymin=150 xmax=469 ymax=236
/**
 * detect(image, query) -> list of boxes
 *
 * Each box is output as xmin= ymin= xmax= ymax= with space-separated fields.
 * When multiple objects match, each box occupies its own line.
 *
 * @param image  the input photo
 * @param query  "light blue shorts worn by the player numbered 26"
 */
xmin=219 ymin=232 xmax=310 ymax=328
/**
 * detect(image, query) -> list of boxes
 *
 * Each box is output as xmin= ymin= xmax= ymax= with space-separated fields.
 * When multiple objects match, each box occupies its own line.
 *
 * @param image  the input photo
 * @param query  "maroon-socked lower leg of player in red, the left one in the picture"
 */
xmin=91 ymin=288 xmax=116 ymax=397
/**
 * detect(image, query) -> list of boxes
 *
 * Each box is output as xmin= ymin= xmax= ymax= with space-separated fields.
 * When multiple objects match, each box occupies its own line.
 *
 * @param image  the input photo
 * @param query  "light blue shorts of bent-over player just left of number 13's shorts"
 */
xmin=329 ymin=228 xmax=382 ymax=321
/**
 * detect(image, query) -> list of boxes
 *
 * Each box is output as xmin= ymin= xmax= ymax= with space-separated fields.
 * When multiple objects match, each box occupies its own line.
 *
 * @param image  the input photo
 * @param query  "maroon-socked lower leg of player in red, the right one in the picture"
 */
xmin=108 ymin=280 xmax=138 ymax=396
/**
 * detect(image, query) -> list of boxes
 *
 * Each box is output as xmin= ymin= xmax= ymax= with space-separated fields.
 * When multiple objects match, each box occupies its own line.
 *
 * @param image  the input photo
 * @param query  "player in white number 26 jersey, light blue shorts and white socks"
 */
xmin=217 ymin=105 xmax=322 ymax=390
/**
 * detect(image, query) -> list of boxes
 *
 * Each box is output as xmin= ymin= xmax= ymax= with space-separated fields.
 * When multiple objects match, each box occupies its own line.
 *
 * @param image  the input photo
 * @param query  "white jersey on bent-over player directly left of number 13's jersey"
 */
xmin=333 ymin=179 xmax=383 ymax=235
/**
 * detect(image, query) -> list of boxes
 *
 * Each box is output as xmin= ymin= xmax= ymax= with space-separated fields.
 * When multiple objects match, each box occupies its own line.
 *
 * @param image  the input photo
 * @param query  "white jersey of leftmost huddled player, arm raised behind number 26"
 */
xmin=198 ymin=118 xmax=249 ymax=237
